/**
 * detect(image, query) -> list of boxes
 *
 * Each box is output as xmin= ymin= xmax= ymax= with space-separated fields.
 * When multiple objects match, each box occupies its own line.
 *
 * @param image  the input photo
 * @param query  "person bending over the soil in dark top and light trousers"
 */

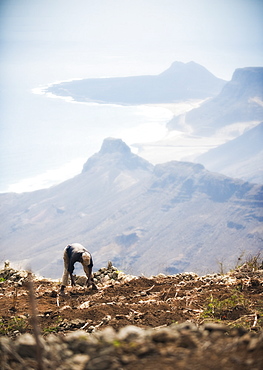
xmin=60 ymin=243 xmax=98 ymax=292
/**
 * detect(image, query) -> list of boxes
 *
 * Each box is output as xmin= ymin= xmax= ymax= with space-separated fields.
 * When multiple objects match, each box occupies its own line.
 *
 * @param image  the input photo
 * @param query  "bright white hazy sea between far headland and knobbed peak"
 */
xmin=0 ymin=81 xmax=173 ymax=193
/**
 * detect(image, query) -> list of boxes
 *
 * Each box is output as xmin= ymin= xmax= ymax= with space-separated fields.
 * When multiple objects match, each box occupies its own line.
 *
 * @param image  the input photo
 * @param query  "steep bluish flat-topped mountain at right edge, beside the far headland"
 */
xmin=168 ymin=67 xmax=263 ymax=136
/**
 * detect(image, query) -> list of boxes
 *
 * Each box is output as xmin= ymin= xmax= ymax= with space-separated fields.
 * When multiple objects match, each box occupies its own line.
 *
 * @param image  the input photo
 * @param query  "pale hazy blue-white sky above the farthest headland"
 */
xmin=0 ymin=0 xmax=263 ymax=82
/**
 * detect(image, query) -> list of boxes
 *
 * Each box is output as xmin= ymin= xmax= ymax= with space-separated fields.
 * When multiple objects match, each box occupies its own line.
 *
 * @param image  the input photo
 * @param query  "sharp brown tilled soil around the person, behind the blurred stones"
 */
xmin=0 ymin=270 xmax=263 ymax=369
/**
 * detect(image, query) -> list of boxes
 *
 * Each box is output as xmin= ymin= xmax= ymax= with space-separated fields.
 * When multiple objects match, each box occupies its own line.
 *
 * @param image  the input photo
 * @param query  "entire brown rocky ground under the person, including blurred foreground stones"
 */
xmin=0 ymin=263 xmax=263 ymax=370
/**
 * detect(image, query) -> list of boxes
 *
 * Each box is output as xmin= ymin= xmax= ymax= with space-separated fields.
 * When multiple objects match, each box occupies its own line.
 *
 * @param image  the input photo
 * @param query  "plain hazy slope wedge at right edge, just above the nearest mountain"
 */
xmin=195 ymin=122 xmax=263 ymax=184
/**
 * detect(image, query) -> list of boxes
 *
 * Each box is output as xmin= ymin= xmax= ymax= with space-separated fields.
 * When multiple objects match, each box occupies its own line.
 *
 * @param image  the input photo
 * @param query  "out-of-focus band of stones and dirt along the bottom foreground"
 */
xmin=0 ymin=323 xmax=263 ymax=370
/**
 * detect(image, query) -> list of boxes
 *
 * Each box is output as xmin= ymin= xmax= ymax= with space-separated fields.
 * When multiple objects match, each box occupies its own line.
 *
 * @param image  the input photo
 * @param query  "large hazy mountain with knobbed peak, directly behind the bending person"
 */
xmin=0 ymin=138 xmax=263 ymax=278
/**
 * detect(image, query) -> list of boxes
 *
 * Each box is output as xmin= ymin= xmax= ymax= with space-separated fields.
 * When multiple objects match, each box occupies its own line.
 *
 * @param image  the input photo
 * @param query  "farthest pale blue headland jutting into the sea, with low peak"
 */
xmin=46 ymin=62 xmax=225 ymax=104
